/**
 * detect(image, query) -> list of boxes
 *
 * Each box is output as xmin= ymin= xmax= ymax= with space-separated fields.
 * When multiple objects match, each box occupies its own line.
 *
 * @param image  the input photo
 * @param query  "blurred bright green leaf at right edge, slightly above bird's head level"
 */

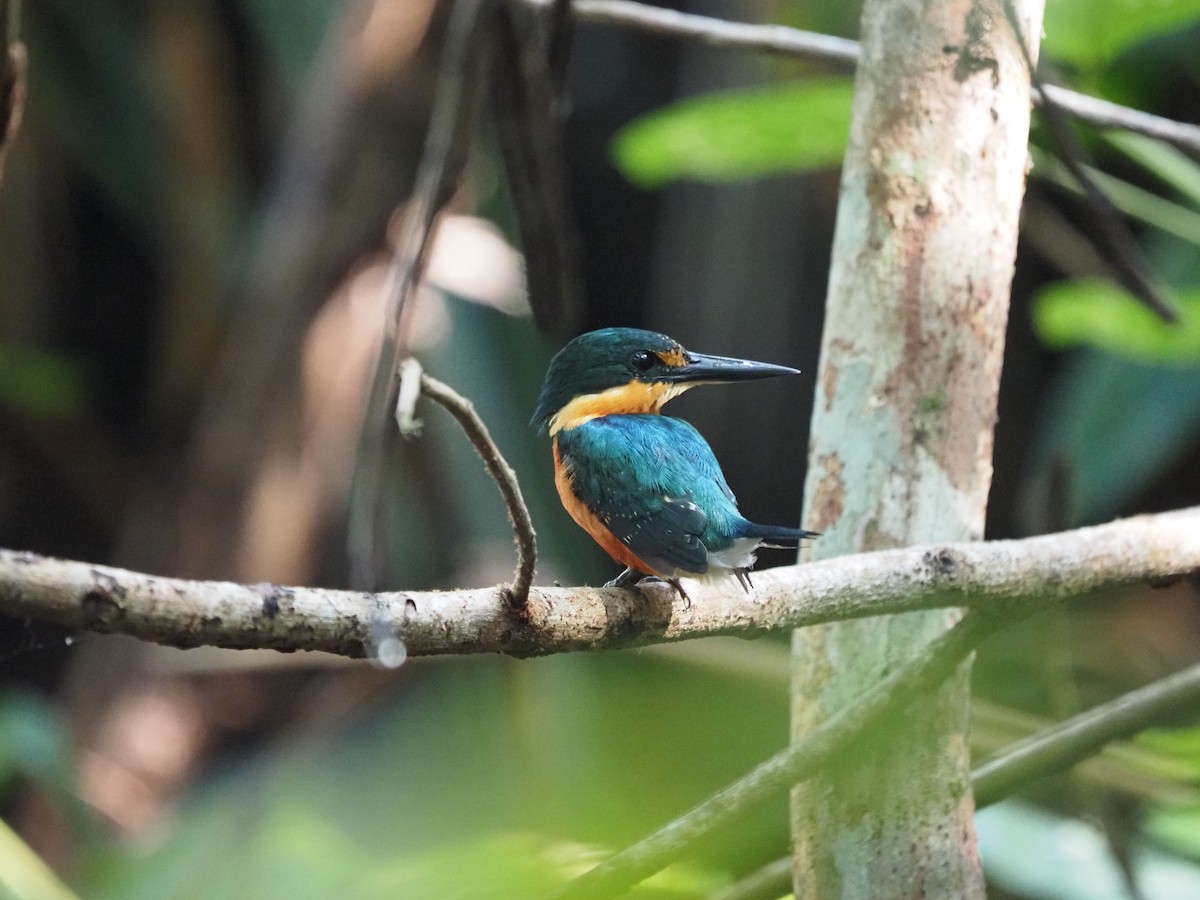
xmin=1033 ymin=280 xmax=1200 ymax=366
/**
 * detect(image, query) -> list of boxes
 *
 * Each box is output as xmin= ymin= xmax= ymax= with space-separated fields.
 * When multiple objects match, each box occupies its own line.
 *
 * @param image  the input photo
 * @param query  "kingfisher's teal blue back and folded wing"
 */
xmin=558 ymin=415 xmax=744 ymax=575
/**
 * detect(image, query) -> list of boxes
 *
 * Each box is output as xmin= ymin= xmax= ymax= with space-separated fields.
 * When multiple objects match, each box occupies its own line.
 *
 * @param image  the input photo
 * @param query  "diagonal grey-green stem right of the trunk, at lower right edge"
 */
xmin=971 ymin=666 xmax=1200 ymax=809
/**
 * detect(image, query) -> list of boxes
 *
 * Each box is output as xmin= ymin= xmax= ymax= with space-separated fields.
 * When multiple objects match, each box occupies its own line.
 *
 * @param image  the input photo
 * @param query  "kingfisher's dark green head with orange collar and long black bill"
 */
xmin=533 ymin=328 xmax=798 ymax=434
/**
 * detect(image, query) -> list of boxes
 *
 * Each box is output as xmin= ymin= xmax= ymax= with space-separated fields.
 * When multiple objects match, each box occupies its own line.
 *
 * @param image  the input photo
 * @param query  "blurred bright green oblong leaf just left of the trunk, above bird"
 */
xmin=612 ymin=78 xmax=854 ymax=187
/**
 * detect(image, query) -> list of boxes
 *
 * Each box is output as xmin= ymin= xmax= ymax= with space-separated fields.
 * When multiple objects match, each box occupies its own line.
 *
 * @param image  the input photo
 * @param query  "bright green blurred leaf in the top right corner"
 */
xmin=1042 ymin=0 xmax=1200 ymax=68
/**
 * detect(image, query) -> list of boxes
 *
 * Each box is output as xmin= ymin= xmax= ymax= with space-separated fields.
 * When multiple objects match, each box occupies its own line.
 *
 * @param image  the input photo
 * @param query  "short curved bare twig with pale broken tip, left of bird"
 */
xmin=396 ymin=358 xmax=538 ymax=608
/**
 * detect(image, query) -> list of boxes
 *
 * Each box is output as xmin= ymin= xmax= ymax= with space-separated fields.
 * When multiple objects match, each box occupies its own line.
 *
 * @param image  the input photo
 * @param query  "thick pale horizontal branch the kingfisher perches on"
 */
xmin=0 ymin=506 xmax=1200 ymax=656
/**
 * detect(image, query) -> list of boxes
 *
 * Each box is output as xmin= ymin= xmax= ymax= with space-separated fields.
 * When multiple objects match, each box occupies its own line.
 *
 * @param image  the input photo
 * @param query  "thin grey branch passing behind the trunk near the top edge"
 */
xmin=547 ymin=0 xmax=1200 ymax=152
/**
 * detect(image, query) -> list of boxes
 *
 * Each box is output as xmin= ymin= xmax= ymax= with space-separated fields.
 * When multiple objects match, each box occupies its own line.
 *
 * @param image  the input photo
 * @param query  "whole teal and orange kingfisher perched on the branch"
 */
xmin=533 ymin=328 xmax=816 ymax=599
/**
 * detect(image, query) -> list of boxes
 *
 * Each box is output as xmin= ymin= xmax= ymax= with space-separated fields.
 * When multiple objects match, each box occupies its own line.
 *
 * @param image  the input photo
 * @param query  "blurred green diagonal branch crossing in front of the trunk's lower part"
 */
xmin=557 ymin=611 xmax=1004 ymax=898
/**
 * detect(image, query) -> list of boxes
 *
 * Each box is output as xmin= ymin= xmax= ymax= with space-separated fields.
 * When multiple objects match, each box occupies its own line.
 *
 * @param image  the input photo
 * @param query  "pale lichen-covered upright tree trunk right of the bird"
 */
xmin=792 ymin=0 xmax=1043 ymax=900
